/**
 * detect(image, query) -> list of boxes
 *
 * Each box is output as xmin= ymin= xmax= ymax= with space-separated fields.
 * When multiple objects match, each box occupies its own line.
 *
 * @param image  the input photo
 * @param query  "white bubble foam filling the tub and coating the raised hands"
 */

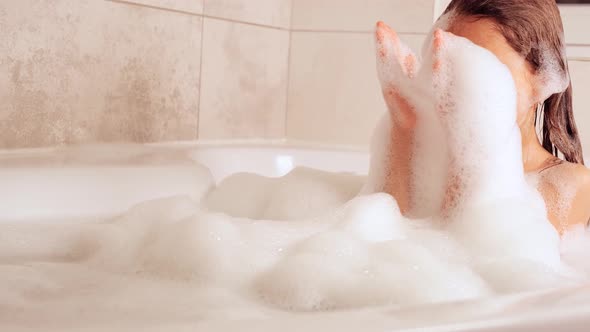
xmin=0 ymin=22 xmax=590 ymax=330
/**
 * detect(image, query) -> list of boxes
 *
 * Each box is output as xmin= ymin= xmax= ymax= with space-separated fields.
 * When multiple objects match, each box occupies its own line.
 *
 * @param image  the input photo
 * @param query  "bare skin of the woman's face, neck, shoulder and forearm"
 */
xmin=377 ymin=17 xmax=590 ymax=234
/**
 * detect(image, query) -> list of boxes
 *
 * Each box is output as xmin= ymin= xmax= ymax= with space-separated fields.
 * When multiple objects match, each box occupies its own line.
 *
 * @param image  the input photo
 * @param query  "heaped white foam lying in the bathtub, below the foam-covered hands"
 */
xmin=0 ymin=169 xmax=590 ymax=331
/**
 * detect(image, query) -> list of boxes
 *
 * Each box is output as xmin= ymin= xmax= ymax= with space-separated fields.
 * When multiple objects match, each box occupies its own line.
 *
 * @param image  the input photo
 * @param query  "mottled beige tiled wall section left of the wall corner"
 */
xmin=0 ymin=0 xmax=291 ymax=148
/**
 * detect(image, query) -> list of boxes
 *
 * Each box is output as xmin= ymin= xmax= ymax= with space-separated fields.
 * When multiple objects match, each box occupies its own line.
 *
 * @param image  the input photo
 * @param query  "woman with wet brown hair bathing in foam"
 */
xmin=378 ymin=0 xmax=590 ymax=233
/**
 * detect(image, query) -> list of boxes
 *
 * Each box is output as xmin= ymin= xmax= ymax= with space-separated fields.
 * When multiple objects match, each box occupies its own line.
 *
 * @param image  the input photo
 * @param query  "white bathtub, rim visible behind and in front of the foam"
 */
xmin=0 ymin=144 xmax=590 ymax=331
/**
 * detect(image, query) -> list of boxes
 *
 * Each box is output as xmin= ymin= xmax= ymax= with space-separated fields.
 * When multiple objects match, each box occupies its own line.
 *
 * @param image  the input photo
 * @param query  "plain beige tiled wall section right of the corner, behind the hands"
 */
xmin=287 ymin=0 xmax=435 ymax=146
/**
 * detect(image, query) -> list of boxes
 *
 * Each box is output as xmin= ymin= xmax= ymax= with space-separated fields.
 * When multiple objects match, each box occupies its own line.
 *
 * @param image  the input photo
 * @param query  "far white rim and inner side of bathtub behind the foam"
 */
xmin=0 ymin=144 xmax=369 ymax=220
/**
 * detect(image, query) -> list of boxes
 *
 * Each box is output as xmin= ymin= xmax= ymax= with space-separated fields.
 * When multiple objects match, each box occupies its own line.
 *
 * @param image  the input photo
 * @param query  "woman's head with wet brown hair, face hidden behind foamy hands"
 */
xmin=444 ymin=0 xmax=583 ymax=163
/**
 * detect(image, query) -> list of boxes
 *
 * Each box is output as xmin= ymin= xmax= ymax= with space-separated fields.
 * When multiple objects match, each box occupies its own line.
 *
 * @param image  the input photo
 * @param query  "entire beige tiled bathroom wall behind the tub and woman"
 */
xmin=0 ymin=0 xmax=590 ymax=154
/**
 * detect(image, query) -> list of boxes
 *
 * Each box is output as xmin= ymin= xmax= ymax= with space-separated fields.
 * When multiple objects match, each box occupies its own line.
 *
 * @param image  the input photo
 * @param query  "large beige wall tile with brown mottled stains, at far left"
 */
xmin=0 ymin=0 xmax=202 ymax=148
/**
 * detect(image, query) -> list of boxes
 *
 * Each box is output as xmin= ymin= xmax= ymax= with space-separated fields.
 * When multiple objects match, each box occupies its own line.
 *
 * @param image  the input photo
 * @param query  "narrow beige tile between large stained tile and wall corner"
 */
xmin=199 ymin=18 xmax=289 ymax=139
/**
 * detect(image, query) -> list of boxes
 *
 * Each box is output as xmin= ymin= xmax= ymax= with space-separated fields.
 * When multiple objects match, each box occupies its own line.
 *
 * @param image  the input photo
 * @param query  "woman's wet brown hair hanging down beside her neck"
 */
xmin=445 ymin=0 xmax=584 ymax=164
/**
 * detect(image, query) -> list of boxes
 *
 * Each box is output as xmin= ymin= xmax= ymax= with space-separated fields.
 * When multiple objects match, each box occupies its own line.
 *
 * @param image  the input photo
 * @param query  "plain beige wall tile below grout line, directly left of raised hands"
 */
xmin=287 ymin=32 xmax=424 ymax=145
